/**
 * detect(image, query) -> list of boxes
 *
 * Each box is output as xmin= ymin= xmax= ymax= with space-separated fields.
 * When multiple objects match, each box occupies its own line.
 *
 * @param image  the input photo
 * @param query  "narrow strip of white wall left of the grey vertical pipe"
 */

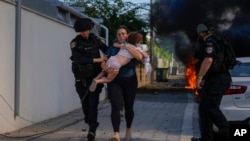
xmin=0 ymin=1 xmax=15 ymax=132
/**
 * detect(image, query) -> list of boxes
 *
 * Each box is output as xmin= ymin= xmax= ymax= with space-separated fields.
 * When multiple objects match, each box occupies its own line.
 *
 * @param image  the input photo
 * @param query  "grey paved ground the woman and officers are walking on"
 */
xmin=0 ymin=91 xmax=199 ymax=141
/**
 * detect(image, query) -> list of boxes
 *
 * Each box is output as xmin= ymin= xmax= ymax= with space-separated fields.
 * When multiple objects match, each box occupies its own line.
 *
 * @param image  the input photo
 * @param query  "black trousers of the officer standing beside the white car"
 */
xmin=199 ymin=75 xmax=231 ymax=141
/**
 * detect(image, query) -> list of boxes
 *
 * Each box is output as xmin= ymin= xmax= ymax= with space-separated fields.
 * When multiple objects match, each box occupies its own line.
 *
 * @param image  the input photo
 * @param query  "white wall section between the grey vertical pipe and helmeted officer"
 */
xmin=20 ymin=10 xmax=79 ymax=122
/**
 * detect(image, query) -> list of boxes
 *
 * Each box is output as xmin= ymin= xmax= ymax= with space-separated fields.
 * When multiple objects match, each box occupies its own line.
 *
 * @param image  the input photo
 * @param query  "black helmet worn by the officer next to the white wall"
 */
xmin=74 ymin=18 xmax=94 ymax=32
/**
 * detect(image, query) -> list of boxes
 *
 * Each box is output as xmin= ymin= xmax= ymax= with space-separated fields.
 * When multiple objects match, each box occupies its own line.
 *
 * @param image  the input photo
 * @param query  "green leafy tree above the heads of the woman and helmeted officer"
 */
xmin=71 ymin=0 xmax=150 ymax=43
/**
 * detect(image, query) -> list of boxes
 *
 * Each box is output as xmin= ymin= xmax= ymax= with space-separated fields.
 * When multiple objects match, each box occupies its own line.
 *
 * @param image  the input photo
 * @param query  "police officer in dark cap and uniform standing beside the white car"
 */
xmin=191 ymin=24 xmax=231 ymax=141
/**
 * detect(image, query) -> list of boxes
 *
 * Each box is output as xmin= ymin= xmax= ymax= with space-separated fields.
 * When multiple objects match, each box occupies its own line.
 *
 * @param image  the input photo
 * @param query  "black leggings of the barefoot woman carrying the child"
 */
xmin=108 ymin=75 xmax=138 ymax=132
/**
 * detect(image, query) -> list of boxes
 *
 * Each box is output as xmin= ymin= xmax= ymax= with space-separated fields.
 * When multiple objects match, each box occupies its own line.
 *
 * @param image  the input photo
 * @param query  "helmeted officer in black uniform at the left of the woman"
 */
xmin=70 ymin=18 xmax=107 ymax=141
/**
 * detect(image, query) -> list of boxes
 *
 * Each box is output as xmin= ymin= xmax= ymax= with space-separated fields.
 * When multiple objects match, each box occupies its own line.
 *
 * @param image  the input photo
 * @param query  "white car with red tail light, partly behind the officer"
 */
xmin=220 ymin=57 xmax=250 ymax=124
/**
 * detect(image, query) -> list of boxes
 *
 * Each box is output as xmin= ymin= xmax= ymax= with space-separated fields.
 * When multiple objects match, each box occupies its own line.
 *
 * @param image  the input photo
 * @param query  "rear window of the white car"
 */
xmin=230 ymin=63 xmax=250 ymax=77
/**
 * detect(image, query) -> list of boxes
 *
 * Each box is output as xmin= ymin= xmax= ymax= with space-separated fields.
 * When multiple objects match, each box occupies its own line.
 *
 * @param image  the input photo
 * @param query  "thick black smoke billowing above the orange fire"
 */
xmin=151 ymin=0 xmax=250 ymax=62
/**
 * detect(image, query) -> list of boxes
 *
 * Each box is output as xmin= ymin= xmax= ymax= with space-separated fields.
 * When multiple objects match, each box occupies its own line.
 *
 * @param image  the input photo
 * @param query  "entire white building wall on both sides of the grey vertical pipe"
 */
xmin=0 ymin=0 xmax=104 ymax=133
